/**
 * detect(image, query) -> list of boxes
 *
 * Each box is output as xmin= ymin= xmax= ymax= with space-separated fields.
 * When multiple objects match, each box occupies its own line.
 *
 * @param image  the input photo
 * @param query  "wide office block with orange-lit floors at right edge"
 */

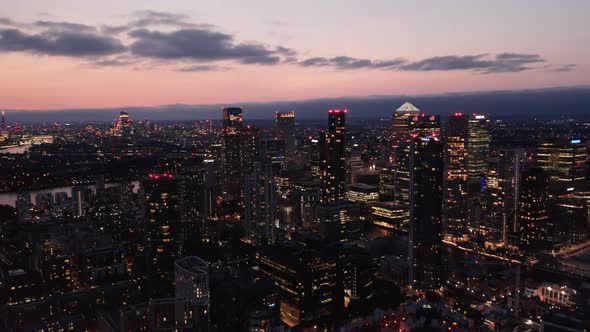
xmin=537 ymin=138 xmax=588 ymax=184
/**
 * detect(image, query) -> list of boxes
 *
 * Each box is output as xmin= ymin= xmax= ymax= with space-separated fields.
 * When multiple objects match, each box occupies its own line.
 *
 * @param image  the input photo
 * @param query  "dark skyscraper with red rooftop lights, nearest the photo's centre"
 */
xmin=319 ymin=109 xmax=348 ymax=203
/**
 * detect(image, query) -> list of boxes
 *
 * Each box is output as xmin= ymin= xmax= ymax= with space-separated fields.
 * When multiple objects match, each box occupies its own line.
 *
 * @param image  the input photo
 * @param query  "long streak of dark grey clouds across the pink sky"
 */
xmin=0 ymin=11 xmax=576 ymax=74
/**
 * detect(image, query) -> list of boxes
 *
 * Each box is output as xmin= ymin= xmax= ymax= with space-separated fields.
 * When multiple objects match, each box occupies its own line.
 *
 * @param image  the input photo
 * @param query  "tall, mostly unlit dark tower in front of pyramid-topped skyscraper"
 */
xmin=410 ymin=137 xmax=443 ymax=289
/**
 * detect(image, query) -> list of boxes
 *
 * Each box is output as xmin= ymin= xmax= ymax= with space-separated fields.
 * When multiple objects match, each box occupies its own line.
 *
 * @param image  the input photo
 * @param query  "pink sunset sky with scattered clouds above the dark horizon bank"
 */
xmin=0 ymin=0 xmax=590 ymax=110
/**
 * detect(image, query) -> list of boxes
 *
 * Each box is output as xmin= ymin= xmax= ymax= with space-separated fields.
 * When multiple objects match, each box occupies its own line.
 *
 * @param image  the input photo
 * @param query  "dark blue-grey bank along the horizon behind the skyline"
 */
xmin=7 ymin=86 xmax=590 ymax=123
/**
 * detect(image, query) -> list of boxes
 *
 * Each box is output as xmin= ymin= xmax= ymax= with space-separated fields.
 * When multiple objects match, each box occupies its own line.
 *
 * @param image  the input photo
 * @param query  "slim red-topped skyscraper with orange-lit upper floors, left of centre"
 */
xmin=221 ymin=107 xmax=243 ymax=202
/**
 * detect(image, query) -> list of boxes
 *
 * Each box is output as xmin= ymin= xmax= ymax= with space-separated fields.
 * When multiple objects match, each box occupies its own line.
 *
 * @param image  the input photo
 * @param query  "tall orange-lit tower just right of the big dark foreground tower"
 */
xmin=444 ymin=113 xmax=468 ymax=241
